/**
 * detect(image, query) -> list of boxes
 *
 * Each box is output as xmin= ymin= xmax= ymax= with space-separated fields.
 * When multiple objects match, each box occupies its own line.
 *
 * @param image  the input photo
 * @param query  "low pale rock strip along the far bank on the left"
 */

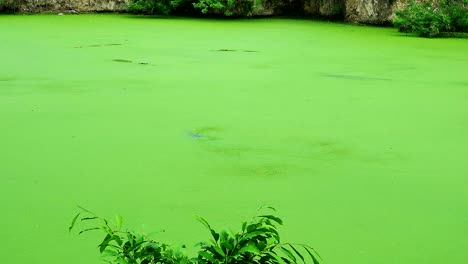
xmin=18 ymin=0 xmax=128 ymax=13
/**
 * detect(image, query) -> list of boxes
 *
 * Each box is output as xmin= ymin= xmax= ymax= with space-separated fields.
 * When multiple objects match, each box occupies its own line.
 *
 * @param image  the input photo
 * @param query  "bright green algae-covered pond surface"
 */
xmin=0 ymin=15 xmax=468 ymax=264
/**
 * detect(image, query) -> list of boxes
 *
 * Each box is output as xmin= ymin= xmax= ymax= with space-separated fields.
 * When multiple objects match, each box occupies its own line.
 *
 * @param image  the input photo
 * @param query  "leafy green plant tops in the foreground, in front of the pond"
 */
xmin=69 ymin=207 xmax=320 ymax=264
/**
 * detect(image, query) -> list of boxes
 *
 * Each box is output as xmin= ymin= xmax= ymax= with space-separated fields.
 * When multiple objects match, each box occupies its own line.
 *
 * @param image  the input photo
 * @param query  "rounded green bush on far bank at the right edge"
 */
xmin=394 ymin=0 xmax=468 ymax=37
